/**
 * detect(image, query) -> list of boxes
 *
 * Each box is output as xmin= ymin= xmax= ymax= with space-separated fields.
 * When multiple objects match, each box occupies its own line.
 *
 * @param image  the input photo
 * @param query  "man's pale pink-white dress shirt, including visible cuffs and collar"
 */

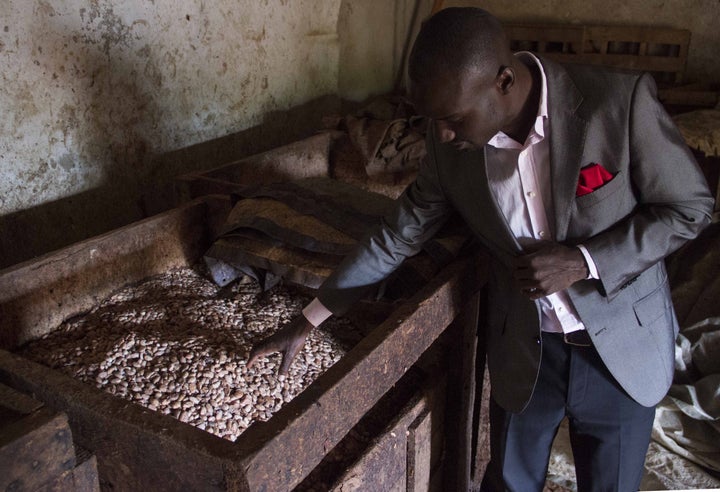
xmin=303 ymin=52 xmax=598 ymax=333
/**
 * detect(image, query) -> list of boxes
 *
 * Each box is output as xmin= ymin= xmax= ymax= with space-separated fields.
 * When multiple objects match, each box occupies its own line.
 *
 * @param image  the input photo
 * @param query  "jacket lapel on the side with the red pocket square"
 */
xmin=541 ymin=58 xmax=587 ymax=242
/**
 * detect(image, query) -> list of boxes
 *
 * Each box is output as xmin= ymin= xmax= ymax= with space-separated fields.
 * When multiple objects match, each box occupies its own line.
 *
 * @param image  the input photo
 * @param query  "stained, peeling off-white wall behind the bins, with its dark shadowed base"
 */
xmin=0 ymin=0 xmax=341 ymax=267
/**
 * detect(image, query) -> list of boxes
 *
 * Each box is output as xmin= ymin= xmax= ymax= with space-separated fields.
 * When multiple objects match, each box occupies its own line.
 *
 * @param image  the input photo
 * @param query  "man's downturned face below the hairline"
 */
xmin=410 ymin=68 xmax=506 ymax=150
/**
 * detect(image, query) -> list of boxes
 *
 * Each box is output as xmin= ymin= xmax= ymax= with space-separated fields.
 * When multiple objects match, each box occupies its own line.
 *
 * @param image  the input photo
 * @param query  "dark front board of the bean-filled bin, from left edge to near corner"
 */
xmin=0 ymin=350 xmax=240 ymax=491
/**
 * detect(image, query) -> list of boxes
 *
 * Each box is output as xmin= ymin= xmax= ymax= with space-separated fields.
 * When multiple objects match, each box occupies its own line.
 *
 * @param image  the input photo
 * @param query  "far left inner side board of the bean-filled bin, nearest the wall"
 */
xmin=0 ymin=197 xmax=230 ymax=349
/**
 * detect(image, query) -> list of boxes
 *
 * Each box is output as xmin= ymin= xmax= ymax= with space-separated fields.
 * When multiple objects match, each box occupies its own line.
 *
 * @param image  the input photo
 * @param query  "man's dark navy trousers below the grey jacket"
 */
xmin=481 ymin=333 xmax=655 ymax=492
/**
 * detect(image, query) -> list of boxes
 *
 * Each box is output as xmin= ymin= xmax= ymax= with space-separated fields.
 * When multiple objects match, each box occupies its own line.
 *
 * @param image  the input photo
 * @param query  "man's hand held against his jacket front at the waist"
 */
xmin=513 ymin=242 xmax=588 ymax=300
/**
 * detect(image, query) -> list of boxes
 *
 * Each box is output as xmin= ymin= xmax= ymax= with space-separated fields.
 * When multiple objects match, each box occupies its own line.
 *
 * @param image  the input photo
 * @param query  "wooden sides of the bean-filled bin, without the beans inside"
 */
xmin=0 ymin=196 xmax=484 ymax=490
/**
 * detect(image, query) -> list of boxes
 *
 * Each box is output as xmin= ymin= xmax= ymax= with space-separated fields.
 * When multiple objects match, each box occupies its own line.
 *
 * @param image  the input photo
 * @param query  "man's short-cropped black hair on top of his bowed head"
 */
xmin=408 ymin=7 xmax=511 ymax=82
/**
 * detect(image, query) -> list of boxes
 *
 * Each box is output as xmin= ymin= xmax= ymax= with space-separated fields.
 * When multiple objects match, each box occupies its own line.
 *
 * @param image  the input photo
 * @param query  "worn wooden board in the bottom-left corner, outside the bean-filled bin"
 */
xmin=0 ymin=408 xmax=75 ymax=491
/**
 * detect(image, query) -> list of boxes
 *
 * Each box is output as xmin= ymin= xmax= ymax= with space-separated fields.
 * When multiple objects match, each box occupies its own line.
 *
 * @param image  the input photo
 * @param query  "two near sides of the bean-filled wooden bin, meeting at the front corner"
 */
xmin=0 ymin=259 xmax=483 ymax=491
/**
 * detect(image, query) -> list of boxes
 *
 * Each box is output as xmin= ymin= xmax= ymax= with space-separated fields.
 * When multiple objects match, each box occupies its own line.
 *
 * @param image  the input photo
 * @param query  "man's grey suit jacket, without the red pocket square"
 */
xmin=318 ymin=59 xmax=713 ymax=412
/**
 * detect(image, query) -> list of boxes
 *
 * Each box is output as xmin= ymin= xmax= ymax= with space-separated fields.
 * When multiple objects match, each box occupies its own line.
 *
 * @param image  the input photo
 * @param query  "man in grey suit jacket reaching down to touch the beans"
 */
xmin=249 ymin=8 xmax=713 ymax=491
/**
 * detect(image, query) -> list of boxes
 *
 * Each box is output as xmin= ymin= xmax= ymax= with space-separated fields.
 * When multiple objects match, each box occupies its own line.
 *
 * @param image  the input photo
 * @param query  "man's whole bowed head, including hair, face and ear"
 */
xmin=408 ymin=8 xmax=527 ymax=149
